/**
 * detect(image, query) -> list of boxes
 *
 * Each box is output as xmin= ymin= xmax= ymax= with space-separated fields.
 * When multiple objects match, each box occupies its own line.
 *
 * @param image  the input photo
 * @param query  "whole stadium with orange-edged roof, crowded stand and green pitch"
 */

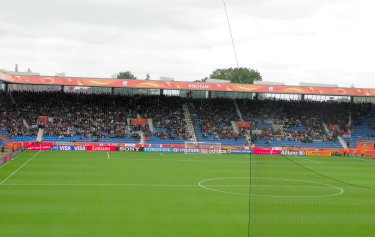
xmin=0 ymin=72 xmax=375 ymax=237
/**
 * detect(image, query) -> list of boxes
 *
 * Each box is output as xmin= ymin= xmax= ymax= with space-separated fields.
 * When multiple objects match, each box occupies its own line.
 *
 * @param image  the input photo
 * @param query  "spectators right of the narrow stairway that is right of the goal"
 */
xmin=238 ymin=100 xmax=374 ymax=143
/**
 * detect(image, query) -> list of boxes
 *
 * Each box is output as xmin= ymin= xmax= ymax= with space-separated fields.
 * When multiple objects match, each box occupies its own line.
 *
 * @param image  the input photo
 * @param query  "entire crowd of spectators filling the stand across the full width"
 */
xmin=0 ymin=91 xmax=375 ymax=145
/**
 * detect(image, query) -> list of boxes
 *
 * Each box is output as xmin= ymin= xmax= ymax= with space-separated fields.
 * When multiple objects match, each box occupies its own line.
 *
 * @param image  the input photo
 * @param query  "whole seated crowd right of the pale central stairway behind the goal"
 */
xmin=192 ymin=99 xmax=373 ymax=143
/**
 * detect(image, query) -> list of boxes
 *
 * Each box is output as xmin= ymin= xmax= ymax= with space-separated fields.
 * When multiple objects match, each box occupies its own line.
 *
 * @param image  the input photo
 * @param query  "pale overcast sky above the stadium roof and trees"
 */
xmin=0 ymin=0 xmax=375 ymax=88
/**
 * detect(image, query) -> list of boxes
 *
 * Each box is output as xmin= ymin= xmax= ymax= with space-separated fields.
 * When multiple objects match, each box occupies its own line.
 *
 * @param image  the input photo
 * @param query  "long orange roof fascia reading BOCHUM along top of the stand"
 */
xmin=0 ymin=72 xmax=375 ymax=96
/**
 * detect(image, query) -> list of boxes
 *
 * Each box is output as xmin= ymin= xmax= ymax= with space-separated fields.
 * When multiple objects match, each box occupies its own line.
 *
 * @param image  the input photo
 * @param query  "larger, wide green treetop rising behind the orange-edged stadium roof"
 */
xmin=206 ymin=67 xmax=262 ymax=84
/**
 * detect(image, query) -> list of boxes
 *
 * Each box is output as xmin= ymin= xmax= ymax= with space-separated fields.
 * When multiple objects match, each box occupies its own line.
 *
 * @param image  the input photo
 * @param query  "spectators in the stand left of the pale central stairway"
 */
xmin=0 ymin=91 xmax=187 ymax=140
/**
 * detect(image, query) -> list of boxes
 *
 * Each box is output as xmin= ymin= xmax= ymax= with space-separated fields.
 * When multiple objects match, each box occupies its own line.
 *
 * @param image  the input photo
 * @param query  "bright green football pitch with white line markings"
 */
xmin=0 ymin=151 xmax=375 ymax=237
